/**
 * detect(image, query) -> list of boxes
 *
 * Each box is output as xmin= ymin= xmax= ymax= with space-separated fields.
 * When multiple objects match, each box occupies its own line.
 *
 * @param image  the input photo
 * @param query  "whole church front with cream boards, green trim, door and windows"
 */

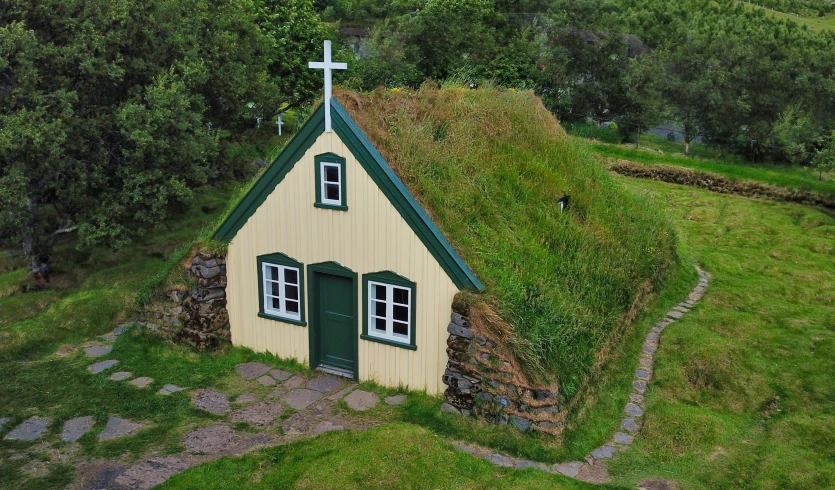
xmin=216 ymin=90 xmax=483 ymax=393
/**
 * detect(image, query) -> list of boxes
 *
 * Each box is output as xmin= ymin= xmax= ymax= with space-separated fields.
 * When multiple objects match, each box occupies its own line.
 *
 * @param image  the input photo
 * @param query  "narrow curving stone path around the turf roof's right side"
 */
xmin=453 ymin=266 xmax=710 ymax=489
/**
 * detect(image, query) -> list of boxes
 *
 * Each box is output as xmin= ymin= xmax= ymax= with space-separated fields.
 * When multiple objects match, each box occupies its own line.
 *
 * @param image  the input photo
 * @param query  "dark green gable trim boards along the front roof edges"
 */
xmin=215 ymin=99 xmax=484 ymax=291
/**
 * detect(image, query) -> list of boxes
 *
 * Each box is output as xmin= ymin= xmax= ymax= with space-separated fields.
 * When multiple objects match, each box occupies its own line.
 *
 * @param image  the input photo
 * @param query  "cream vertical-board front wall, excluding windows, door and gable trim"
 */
xmin=226 ymin=133 xmax=458 ymax=394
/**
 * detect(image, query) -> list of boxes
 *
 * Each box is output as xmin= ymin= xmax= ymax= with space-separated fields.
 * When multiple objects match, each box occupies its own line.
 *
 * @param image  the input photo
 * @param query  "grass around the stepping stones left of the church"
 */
xmin=0 ymin=183 xmax=300 ymax=489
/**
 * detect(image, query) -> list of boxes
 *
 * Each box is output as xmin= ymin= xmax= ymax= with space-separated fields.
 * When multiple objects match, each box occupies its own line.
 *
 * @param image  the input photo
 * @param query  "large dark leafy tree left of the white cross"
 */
xmin=0 ymin=0 xmax=324 ymax=284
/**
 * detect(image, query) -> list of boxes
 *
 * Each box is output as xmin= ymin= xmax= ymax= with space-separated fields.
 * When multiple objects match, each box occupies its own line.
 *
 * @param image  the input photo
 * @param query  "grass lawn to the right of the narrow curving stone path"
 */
xmin=609 ymin=175 xmax=835 ymax=489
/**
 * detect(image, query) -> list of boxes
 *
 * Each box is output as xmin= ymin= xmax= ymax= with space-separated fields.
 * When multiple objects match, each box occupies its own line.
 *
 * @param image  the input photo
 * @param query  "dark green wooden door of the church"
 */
xmin=314 ymin=273 xmax=358 ymax=373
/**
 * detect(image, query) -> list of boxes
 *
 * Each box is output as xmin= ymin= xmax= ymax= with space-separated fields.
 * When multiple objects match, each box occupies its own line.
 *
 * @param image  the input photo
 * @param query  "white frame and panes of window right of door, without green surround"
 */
xmin=368 ymin=281 xmax=414 ymax=344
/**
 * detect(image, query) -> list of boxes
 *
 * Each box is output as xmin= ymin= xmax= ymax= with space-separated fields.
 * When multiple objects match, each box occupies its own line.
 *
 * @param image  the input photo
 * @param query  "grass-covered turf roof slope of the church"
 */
xmin=337 ymin=85 xmax=675 ymax=396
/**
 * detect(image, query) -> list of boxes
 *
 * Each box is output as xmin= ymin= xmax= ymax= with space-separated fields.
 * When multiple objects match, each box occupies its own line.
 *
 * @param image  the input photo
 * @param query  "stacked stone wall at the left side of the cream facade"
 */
xmin=139 ymin=251 xmax=231 ymax=350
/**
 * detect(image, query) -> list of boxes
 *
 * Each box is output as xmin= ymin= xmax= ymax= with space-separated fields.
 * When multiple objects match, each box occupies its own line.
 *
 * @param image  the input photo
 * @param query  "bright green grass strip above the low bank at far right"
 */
xmin=589 ymin=138 xmax=835 ymax=195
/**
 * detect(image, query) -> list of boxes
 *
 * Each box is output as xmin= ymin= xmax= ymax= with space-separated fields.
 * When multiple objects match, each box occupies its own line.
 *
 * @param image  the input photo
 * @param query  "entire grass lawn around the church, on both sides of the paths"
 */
xmin=0 ymin=136 xmax=835 ymax=489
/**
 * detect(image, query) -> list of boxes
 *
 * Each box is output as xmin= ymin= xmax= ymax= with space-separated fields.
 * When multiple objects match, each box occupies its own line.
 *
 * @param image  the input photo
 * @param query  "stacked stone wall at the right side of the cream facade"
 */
xmin=441 ymin=305 xmax=565 ymax=435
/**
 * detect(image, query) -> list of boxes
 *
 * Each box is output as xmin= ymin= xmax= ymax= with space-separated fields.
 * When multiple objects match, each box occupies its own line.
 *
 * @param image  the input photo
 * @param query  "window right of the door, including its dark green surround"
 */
xmin=361 ymin=272 xmax=417 ymax=350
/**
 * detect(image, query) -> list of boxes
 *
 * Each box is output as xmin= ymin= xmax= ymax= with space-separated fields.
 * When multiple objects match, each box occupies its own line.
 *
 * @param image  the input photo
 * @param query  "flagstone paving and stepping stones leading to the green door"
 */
xmin=0 ymin=326 xmax=407 ymax=490
